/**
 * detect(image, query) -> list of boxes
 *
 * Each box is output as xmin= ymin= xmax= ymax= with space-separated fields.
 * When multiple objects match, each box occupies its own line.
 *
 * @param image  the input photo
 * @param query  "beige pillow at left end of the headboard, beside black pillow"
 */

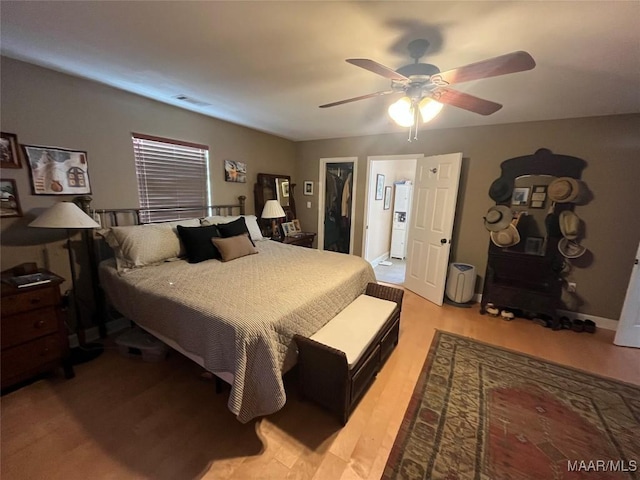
xmin=99 ymin=218 xmax=200 ymax=272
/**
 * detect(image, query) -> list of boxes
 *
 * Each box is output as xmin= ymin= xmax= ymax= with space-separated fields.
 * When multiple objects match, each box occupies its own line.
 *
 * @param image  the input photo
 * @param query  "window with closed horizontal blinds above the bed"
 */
xmin=133 ymin=133 xmax=211 ymax=223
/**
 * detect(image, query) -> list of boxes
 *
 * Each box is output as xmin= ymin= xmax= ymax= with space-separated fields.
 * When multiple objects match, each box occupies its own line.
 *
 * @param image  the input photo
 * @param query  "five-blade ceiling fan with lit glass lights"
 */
xmin=320 ymin=39 xmax=536 ymax=137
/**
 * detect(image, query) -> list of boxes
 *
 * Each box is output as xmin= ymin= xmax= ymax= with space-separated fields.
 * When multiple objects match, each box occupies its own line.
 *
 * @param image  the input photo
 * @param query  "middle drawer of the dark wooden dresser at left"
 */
xmin=2 ymin=307 xmax=58 ymax=348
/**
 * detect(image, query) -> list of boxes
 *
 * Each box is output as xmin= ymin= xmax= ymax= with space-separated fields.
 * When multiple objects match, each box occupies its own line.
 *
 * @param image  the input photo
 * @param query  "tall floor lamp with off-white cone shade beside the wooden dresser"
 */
xmin=29 ymin=202 xmax=103 ymax=363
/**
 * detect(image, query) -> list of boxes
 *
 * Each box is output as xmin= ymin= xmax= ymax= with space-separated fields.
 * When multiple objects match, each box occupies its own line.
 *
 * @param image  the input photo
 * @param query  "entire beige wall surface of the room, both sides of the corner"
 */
xmin=0 ymin=57 xmax=640 ymax=319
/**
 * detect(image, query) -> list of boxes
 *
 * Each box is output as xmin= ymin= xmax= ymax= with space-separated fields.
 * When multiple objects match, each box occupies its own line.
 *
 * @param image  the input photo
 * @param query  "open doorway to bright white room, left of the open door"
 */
xmin=362 ymin=154 xmax=423 ymax=285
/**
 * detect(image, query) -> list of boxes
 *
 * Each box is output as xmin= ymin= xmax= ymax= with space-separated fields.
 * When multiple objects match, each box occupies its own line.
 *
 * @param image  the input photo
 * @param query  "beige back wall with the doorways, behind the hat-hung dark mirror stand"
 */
xmin=296 ymin=114 xmax=640 ymax=319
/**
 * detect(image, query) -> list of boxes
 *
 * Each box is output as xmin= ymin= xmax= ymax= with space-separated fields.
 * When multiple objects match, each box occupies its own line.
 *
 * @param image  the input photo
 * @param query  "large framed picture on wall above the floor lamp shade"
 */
xmin=22 ymin=145 xmax=91 ymax=195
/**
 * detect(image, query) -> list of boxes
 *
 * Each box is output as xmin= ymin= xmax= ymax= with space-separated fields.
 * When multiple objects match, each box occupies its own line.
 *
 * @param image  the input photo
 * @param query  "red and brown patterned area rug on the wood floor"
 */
xmin=382 ymin=332 xmax=640 ymax=480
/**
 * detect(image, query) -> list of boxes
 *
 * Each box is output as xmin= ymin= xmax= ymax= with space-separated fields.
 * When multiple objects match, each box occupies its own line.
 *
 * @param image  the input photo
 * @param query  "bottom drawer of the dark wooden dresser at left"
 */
xmin=2 ymin=334 xmax=62 ymax=385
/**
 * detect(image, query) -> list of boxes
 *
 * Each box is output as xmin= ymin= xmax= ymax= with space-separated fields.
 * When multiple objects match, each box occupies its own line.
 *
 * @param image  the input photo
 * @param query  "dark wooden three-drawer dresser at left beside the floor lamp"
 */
xmin=0 ymin=269 xmax=74 ymax=389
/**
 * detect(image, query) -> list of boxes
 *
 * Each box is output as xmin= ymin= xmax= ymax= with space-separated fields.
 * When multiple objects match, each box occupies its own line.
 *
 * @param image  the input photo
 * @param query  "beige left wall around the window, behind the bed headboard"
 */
xmin=0 ymin=57 xmax=295 ymax=318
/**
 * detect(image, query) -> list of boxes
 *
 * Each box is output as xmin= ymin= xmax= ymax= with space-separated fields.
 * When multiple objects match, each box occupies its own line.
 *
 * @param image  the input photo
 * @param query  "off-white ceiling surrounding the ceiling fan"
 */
xmin=0 ymin=0 xmax=640 ymax=140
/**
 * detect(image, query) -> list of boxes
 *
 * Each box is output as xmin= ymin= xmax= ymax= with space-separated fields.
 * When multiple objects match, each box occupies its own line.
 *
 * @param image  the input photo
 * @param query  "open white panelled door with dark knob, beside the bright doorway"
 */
xmin=404 ymin=153 xmax=462 ymax=305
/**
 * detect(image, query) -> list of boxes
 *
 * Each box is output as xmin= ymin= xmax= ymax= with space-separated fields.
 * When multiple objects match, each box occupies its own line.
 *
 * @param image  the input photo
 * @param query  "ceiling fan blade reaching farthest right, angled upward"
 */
xmin=431 ymin=51 xmax=536 ymax=86
